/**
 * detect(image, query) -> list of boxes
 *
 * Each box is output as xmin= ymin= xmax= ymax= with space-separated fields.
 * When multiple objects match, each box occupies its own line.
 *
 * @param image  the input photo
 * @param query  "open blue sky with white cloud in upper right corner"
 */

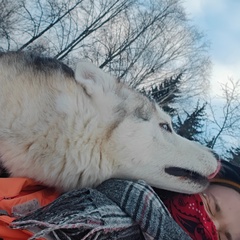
xmin=183 ymin=0 xmax=240 ymax=93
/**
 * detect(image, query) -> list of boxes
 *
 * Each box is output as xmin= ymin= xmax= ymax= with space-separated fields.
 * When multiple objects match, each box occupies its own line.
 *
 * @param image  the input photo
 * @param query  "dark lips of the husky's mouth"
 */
xmin=165 ymin=167 xmax=208 ymax=184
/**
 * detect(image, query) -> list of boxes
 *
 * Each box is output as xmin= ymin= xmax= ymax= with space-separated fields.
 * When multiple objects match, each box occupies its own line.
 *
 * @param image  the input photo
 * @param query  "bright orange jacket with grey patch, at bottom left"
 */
xmin=0 ymin=178 xmax=59 ymax=240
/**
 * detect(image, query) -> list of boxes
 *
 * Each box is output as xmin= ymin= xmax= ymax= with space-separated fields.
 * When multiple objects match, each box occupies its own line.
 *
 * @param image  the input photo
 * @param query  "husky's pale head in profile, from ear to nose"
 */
xmin=75 ymin=63 xmax=219 ymax=193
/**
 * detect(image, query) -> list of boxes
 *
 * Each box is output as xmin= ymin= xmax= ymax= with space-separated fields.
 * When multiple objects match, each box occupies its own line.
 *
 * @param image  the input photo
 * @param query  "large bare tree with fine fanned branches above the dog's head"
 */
xmin=79 ymin=0 xmax=210 ymax=98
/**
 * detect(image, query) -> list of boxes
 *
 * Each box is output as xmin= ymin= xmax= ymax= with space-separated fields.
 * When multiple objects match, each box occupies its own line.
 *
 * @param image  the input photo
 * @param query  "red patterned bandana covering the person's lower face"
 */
xmin=163 ymin=194 xmax=218 ymax=240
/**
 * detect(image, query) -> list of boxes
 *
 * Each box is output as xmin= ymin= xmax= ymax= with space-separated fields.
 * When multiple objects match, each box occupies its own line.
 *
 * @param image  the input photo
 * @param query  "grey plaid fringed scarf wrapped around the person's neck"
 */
xmin=12 ymin=179 xmax=190 ymax=240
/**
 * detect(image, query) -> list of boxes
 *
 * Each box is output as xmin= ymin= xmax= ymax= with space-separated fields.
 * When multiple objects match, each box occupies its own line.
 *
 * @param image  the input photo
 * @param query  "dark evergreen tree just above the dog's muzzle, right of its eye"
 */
xmin=174 ymin=102 xmax=206 ymax=141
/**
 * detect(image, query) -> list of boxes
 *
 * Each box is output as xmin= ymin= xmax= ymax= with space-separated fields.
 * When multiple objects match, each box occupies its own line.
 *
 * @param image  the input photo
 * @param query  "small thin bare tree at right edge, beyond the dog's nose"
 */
xmin=205 ymin=79 xmax=240 ymax=153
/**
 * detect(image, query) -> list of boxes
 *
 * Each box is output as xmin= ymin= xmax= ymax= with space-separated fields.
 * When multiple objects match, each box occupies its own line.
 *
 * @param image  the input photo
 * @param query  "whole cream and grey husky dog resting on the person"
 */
xmin=0 ymin=52 xmax=219 ymax=193
